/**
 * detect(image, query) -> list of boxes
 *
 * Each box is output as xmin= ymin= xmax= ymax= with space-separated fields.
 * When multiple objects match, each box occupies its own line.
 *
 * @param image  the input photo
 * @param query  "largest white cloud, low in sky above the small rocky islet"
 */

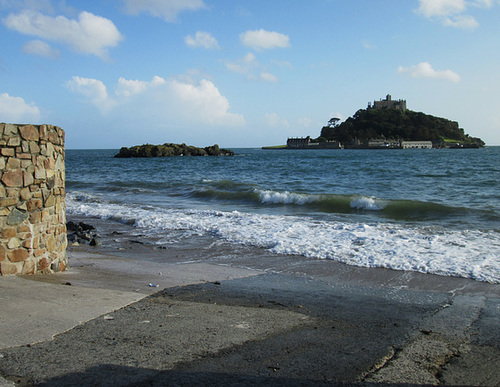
xmin=66 ymin=76 xmax=245 ymax=127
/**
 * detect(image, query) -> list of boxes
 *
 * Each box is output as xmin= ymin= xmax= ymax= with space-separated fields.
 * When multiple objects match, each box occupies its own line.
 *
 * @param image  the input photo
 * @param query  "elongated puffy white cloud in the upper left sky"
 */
xmin=3 ymin=10 xmax=123 ymax=59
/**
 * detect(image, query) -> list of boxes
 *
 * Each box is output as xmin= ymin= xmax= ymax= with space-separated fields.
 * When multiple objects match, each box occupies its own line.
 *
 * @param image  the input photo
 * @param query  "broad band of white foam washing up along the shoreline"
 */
xmin=67 ymin=194 xmax=500 ymax=283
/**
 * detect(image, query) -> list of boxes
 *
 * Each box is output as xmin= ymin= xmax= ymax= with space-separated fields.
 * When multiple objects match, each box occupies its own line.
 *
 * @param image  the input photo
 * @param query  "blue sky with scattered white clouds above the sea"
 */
xmin=0 ymin=0 xmax=500 ymax=149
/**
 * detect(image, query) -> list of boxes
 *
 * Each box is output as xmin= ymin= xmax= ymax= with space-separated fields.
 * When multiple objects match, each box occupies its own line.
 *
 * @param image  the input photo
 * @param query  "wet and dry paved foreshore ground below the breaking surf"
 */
xmin=0 ymin=220 xmax=500 ymax=386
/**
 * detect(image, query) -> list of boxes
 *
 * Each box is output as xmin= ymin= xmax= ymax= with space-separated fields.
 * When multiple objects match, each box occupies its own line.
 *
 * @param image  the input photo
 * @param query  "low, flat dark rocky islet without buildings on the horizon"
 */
xmin=114 ymin=143 xmax=234 ymax=158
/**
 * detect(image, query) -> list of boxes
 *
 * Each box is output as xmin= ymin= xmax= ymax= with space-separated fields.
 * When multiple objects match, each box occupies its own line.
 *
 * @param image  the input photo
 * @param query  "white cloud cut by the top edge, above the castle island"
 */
xmin=415 ymin=0 xmax=495 ymax=29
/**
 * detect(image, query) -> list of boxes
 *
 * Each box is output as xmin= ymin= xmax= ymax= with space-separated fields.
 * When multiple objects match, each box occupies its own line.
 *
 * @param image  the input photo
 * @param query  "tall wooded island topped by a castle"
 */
xmin=264 ymin=94 xmax=485 ymax=149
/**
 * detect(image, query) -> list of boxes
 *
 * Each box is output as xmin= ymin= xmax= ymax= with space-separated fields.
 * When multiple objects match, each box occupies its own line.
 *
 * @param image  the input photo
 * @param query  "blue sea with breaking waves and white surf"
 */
xmin=66 ymin=147 xmax=500 ymax=283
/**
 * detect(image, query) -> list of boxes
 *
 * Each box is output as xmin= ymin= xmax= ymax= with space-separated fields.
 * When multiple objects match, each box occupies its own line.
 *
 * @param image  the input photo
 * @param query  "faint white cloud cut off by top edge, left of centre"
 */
xmin=123 ymin=0 xmax=206 ymax=22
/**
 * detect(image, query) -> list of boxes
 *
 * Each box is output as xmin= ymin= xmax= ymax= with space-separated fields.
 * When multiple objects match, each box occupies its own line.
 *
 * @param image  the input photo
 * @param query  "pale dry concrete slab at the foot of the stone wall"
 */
xmin=0 ymin=253 xmax=261 ymax=348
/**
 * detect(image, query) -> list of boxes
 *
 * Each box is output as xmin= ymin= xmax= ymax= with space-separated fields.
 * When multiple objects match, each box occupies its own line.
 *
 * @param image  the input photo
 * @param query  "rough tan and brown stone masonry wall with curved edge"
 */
xmin=0 ymin=123 xmax=68 ymax=275
